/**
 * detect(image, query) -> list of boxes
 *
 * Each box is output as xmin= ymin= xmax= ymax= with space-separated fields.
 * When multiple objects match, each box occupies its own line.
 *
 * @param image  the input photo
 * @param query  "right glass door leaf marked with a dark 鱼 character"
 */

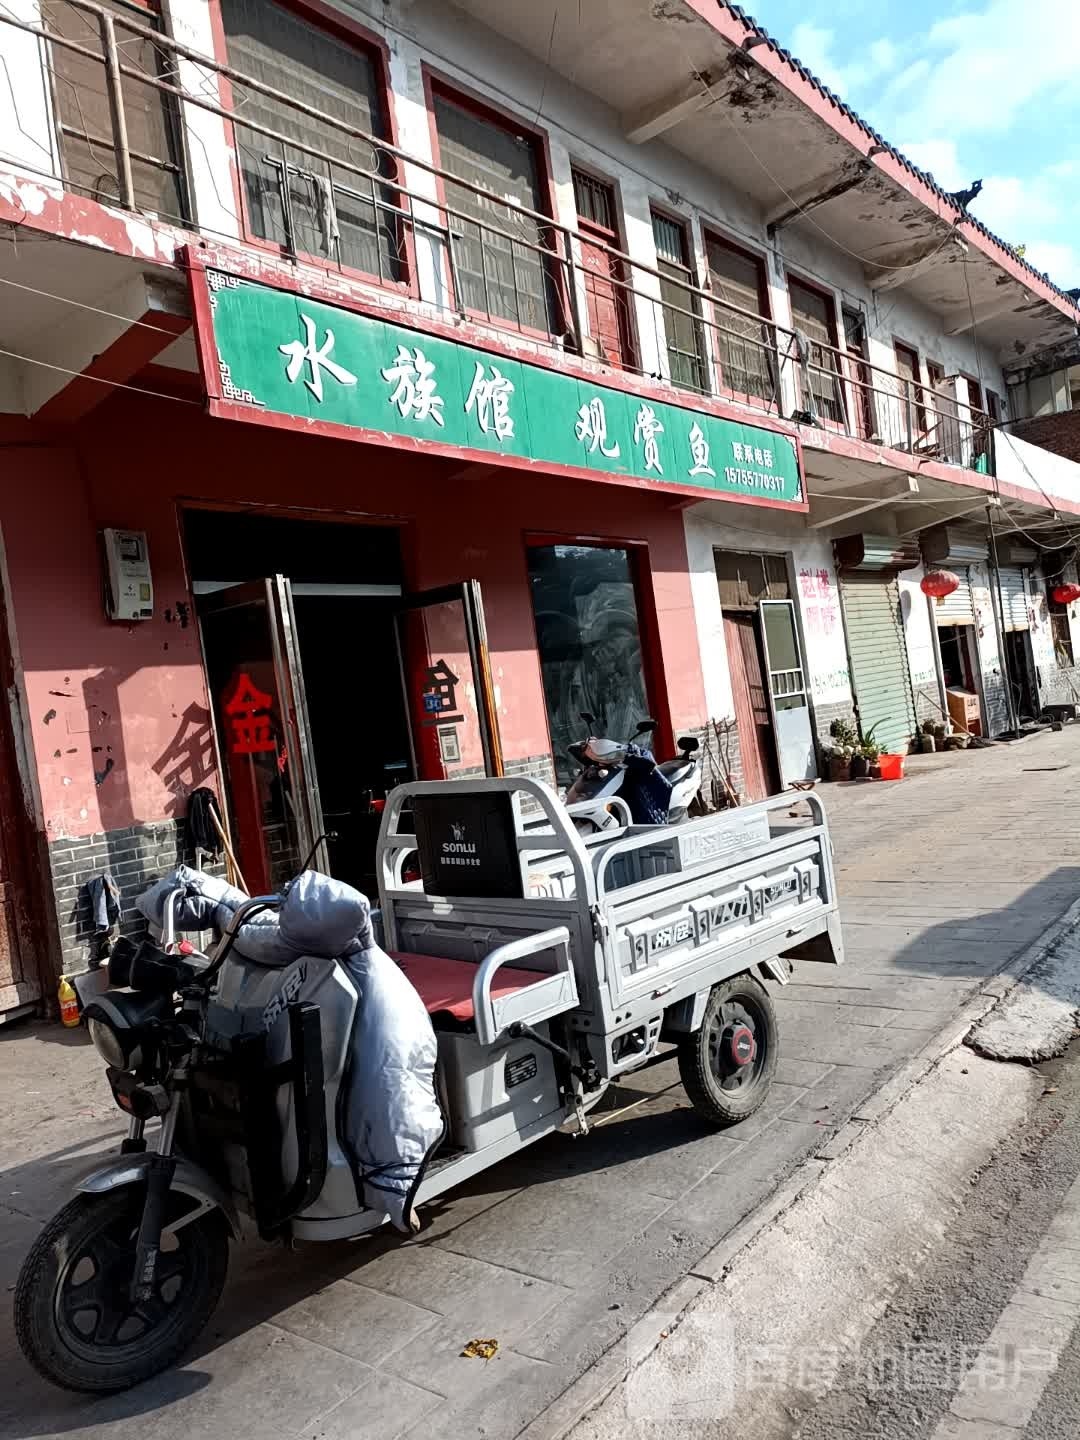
xmin=396 ymin=580 xmax=504 ymax=780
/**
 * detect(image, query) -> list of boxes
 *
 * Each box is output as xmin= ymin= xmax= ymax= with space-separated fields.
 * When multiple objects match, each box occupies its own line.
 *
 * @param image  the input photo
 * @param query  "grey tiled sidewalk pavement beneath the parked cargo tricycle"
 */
xmin=0 ymin=727 xmax=1080 ymax=1440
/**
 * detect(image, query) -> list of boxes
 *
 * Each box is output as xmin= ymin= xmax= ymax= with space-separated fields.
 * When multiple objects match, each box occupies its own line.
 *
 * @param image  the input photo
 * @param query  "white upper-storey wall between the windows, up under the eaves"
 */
xmin=0 ymin=0 xmax=1025 ymax=409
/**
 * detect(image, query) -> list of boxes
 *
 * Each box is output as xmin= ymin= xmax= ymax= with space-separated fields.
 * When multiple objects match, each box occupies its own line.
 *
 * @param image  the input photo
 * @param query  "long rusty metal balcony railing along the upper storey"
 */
xmin=0 ymin=0 xmax=992 ymax=469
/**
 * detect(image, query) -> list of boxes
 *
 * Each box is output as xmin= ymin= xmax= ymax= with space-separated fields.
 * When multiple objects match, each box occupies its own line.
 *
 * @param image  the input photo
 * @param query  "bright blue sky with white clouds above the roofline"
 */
xmin=743 ymin=0 xmax=1080 ymax=289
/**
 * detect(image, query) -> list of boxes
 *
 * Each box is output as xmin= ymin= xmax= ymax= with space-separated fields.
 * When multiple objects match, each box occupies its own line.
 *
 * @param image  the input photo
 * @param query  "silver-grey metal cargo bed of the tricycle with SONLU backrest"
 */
xmin=379 ymin=779 xmax=841 ymax=1076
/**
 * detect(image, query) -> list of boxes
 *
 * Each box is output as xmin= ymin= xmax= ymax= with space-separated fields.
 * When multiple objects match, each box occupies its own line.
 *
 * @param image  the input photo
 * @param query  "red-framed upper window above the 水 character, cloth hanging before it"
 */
xmin=220 ymin=0 xmax=405 ymax=282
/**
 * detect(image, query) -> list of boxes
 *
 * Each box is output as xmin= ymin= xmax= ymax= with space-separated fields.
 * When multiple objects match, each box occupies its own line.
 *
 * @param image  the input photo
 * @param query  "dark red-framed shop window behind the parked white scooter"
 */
xmin=528 ymin=544 xmax=648 ymax=785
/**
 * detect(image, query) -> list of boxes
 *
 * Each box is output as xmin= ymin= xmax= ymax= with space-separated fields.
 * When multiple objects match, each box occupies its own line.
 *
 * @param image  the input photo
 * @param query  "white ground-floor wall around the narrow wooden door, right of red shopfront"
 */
xmin=685 ymin=501 xmax=851 ymax=731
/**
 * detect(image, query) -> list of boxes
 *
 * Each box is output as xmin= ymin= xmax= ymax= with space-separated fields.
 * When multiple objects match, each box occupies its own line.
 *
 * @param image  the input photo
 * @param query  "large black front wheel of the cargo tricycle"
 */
xmin=14 ymin=1187 xmax=229 ymax=1394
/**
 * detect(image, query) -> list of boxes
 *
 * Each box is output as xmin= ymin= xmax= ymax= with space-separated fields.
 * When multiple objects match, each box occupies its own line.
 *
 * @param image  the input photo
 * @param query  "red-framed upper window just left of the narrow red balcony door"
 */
xmin=433 ymin=91 xmax=562 ymax=334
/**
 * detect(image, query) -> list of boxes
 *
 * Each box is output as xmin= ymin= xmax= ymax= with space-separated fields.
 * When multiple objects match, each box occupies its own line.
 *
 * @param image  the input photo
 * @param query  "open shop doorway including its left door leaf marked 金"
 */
xmin=184 ymin=510 xmax=413 ymax=894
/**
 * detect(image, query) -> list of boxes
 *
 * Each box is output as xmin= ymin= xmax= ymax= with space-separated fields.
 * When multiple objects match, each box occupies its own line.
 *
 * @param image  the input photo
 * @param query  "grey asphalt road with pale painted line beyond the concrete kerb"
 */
xmin=791 ymin=1045 xmax=1080 ymax=1440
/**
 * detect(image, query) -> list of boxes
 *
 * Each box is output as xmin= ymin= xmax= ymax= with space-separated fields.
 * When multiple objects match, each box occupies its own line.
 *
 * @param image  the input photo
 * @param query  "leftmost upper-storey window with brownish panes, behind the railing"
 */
xmin=42 ymin=0 xmax=189 ymax=220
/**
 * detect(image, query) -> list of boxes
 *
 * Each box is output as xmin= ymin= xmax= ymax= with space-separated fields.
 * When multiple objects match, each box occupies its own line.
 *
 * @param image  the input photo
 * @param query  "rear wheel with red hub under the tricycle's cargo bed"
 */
xmin=678 ymin=975 xmax=779 ymax=1126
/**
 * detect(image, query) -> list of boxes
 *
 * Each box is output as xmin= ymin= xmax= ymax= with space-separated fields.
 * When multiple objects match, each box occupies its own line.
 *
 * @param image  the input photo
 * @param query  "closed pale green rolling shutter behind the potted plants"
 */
xmin=840 ymin=572 xmax=916 ymax=750
